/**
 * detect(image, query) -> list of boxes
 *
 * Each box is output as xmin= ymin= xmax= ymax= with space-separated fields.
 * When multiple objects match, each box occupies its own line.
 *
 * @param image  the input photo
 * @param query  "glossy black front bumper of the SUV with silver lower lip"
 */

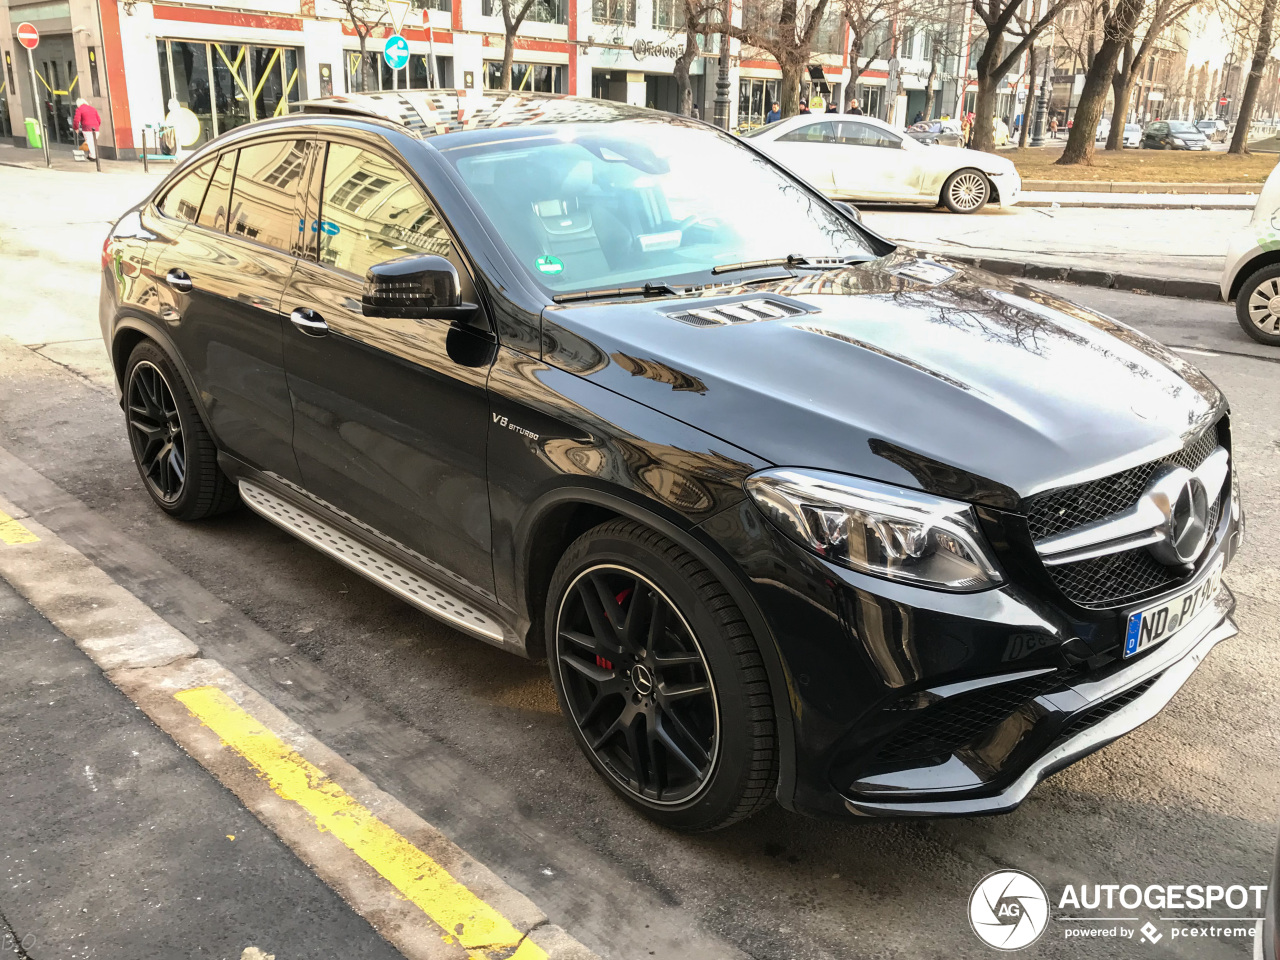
xmin=700 ymin=478 xmax=1240 ymax=817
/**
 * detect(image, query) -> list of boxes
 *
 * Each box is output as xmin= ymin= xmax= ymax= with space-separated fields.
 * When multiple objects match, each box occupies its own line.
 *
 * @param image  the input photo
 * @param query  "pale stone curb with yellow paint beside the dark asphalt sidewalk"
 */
xmin=0 ymin=499 xmax=598 ymax=960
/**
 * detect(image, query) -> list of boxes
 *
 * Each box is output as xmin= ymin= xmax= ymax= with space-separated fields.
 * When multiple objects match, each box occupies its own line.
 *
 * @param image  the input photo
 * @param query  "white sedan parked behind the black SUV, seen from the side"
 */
xmin=746 ymin=114 xmax=1023 ymax=214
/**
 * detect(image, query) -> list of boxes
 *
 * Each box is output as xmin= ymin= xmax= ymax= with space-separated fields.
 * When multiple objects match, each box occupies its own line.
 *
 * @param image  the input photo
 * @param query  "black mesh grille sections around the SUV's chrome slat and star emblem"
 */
xmin=1028 ymin=425 xmax=1230 ymax=609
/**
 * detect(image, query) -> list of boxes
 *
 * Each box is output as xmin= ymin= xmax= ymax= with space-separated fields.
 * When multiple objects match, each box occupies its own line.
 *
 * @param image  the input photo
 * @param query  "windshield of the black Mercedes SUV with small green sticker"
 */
xmin=442 ymin=120 xmax=879 ymax=293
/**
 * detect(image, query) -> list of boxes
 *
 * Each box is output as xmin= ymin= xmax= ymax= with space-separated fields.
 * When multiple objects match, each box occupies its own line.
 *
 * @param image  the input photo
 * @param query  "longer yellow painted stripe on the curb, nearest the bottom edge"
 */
xmin=175 ymin=686 xmax=547 ymax=960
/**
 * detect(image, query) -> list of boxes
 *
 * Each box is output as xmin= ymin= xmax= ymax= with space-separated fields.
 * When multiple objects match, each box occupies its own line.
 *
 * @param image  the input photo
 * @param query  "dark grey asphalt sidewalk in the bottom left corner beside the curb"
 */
xmin=0 ymin=578 xmax=402 ymax=960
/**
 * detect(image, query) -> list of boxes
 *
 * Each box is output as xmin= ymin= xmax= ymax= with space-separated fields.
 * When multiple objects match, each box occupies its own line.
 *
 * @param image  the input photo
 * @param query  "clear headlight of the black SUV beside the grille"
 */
xmin=746 ymin=468 xmax=1001 ymax=591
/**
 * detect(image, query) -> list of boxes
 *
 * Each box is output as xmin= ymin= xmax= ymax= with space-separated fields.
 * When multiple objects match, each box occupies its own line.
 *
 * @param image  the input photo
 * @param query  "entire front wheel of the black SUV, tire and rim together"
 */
xmin=545 ymin=520 xmax=777 ymax=832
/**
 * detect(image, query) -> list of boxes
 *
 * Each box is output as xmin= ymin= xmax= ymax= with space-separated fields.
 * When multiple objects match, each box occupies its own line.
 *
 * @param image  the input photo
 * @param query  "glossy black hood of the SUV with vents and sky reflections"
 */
xmin=543 ymin=251 xmax=1225 ymax=508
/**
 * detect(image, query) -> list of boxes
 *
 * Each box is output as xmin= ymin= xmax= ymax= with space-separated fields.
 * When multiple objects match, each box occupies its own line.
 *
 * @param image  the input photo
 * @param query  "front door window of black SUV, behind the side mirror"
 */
xmin=316 ymin=143 xmax=453 ymax=276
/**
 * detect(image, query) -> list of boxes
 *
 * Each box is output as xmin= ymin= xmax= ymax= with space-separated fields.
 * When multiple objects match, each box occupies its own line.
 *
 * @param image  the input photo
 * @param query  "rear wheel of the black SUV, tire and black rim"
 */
xmin=124 ymin=340 xmax=239 ymax=520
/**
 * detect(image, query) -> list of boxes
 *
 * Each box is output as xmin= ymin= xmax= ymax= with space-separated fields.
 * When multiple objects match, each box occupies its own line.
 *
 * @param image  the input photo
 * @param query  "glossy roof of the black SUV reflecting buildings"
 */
xmin=297 ymin=90 xmax=671 ymax=137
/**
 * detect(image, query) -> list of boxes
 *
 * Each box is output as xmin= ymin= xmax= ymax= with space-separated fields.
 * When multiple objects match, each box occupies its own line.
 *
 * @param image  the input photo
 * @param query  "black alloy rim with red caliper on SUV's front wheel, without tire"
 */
xmin=556 ymin=564 xmax=719 ymax=804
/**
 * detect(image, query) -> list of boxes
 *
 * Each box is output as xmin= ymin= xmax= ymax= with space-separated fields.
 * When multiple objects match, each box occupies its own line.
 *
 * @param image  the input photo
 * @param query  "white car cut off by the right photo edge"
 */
xmin=1221 ymin=166 xmax=1280 ymax=347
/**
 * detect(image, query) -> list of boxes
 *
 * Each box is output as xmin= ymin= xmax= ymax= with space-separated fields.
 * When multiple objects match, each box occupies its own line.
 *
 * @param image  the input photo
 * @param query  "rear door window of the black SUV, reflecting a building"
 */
xmin=228 ymin=140 xmax=306 ymax=252
